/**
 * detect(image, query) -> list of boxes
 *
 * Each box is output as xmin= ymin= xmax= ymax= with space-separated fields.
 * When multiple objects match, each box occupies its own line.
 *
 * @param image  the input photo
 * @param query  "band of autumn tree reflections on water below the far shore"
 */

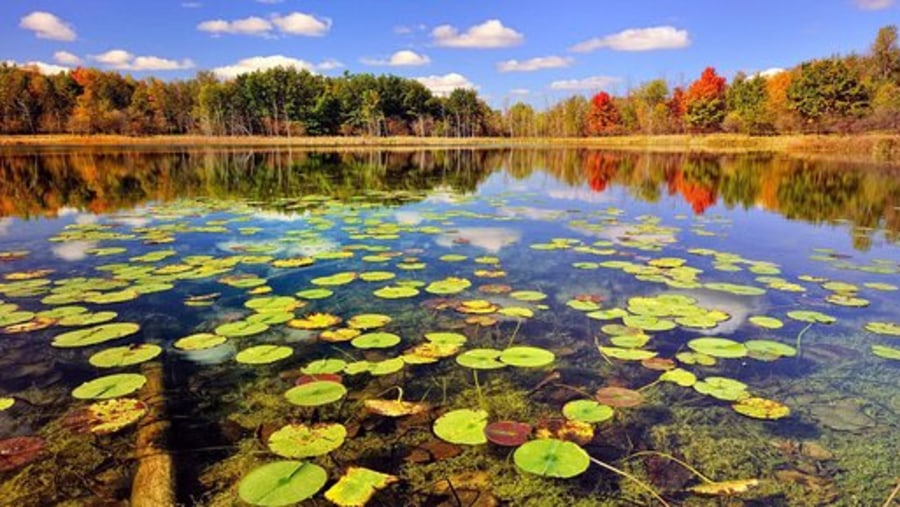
xmin=0 ymin=149 xmax=900 ymax=246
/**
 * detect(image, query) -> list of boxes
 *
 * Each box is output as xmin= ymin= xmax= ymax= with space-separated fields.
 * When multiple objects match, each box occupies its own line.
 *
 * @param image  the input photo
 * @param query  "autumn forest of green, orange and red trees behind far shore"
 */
xmin=0 ymin=25 xmax=900 ymax=137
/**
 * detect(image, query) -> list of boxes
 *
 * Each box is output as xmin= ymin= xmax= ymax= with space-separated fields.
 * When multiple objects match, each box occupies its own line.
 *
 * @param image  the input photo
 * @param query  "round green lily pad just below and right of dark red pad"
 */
xmin=513 ymin=438 xmax=591 ymax=479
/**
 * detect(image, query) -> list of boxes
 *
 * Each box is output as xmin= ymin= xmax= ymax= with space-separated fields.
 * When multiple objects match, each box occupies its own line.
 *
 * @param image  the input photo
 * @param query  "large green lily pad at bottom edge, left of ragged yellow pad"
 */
xmin=238 ymin=461 xmax=328 ymax=507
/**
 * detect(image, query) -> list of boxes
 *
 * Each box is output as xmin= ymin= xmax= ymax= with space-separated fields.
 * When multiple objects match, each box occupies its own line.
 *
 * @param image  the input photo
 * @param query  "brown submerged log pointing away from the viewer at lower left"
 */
xmin=131 ymin=362 xmax=175 ymax=507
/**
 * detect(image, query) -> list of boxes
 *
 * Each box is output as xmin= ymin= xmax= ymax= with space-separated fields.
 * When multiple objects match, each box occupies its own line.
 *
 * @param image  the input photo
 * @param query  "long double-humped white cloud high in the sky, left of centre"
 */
xmin=197 ymin=12 xmax=331 ymax=37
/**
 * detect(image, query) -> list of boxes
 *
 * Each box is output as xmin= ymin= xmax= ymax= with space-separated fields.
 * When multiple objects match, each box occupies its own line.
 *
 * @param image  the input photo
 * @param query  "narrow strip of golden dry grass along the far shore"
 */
xmin=0 ymin=133 xmax=900 ymax=164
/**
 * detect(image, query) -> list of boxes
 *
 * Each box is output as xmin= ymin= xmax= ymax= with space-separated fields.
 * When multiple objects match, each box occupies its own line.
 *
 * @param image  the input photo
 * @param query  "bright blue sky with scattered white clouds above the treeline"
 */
xmin=0 ymin=0 xmax=900 ymax=107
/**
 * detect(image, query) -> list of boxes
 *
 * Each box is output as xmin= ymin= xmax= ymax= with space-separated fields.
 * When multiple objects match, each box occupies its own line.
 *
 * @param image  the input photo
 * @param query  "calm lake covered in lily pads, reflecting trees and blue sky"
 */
xmin=0 ymin=148 xmax=900 ymax=506
